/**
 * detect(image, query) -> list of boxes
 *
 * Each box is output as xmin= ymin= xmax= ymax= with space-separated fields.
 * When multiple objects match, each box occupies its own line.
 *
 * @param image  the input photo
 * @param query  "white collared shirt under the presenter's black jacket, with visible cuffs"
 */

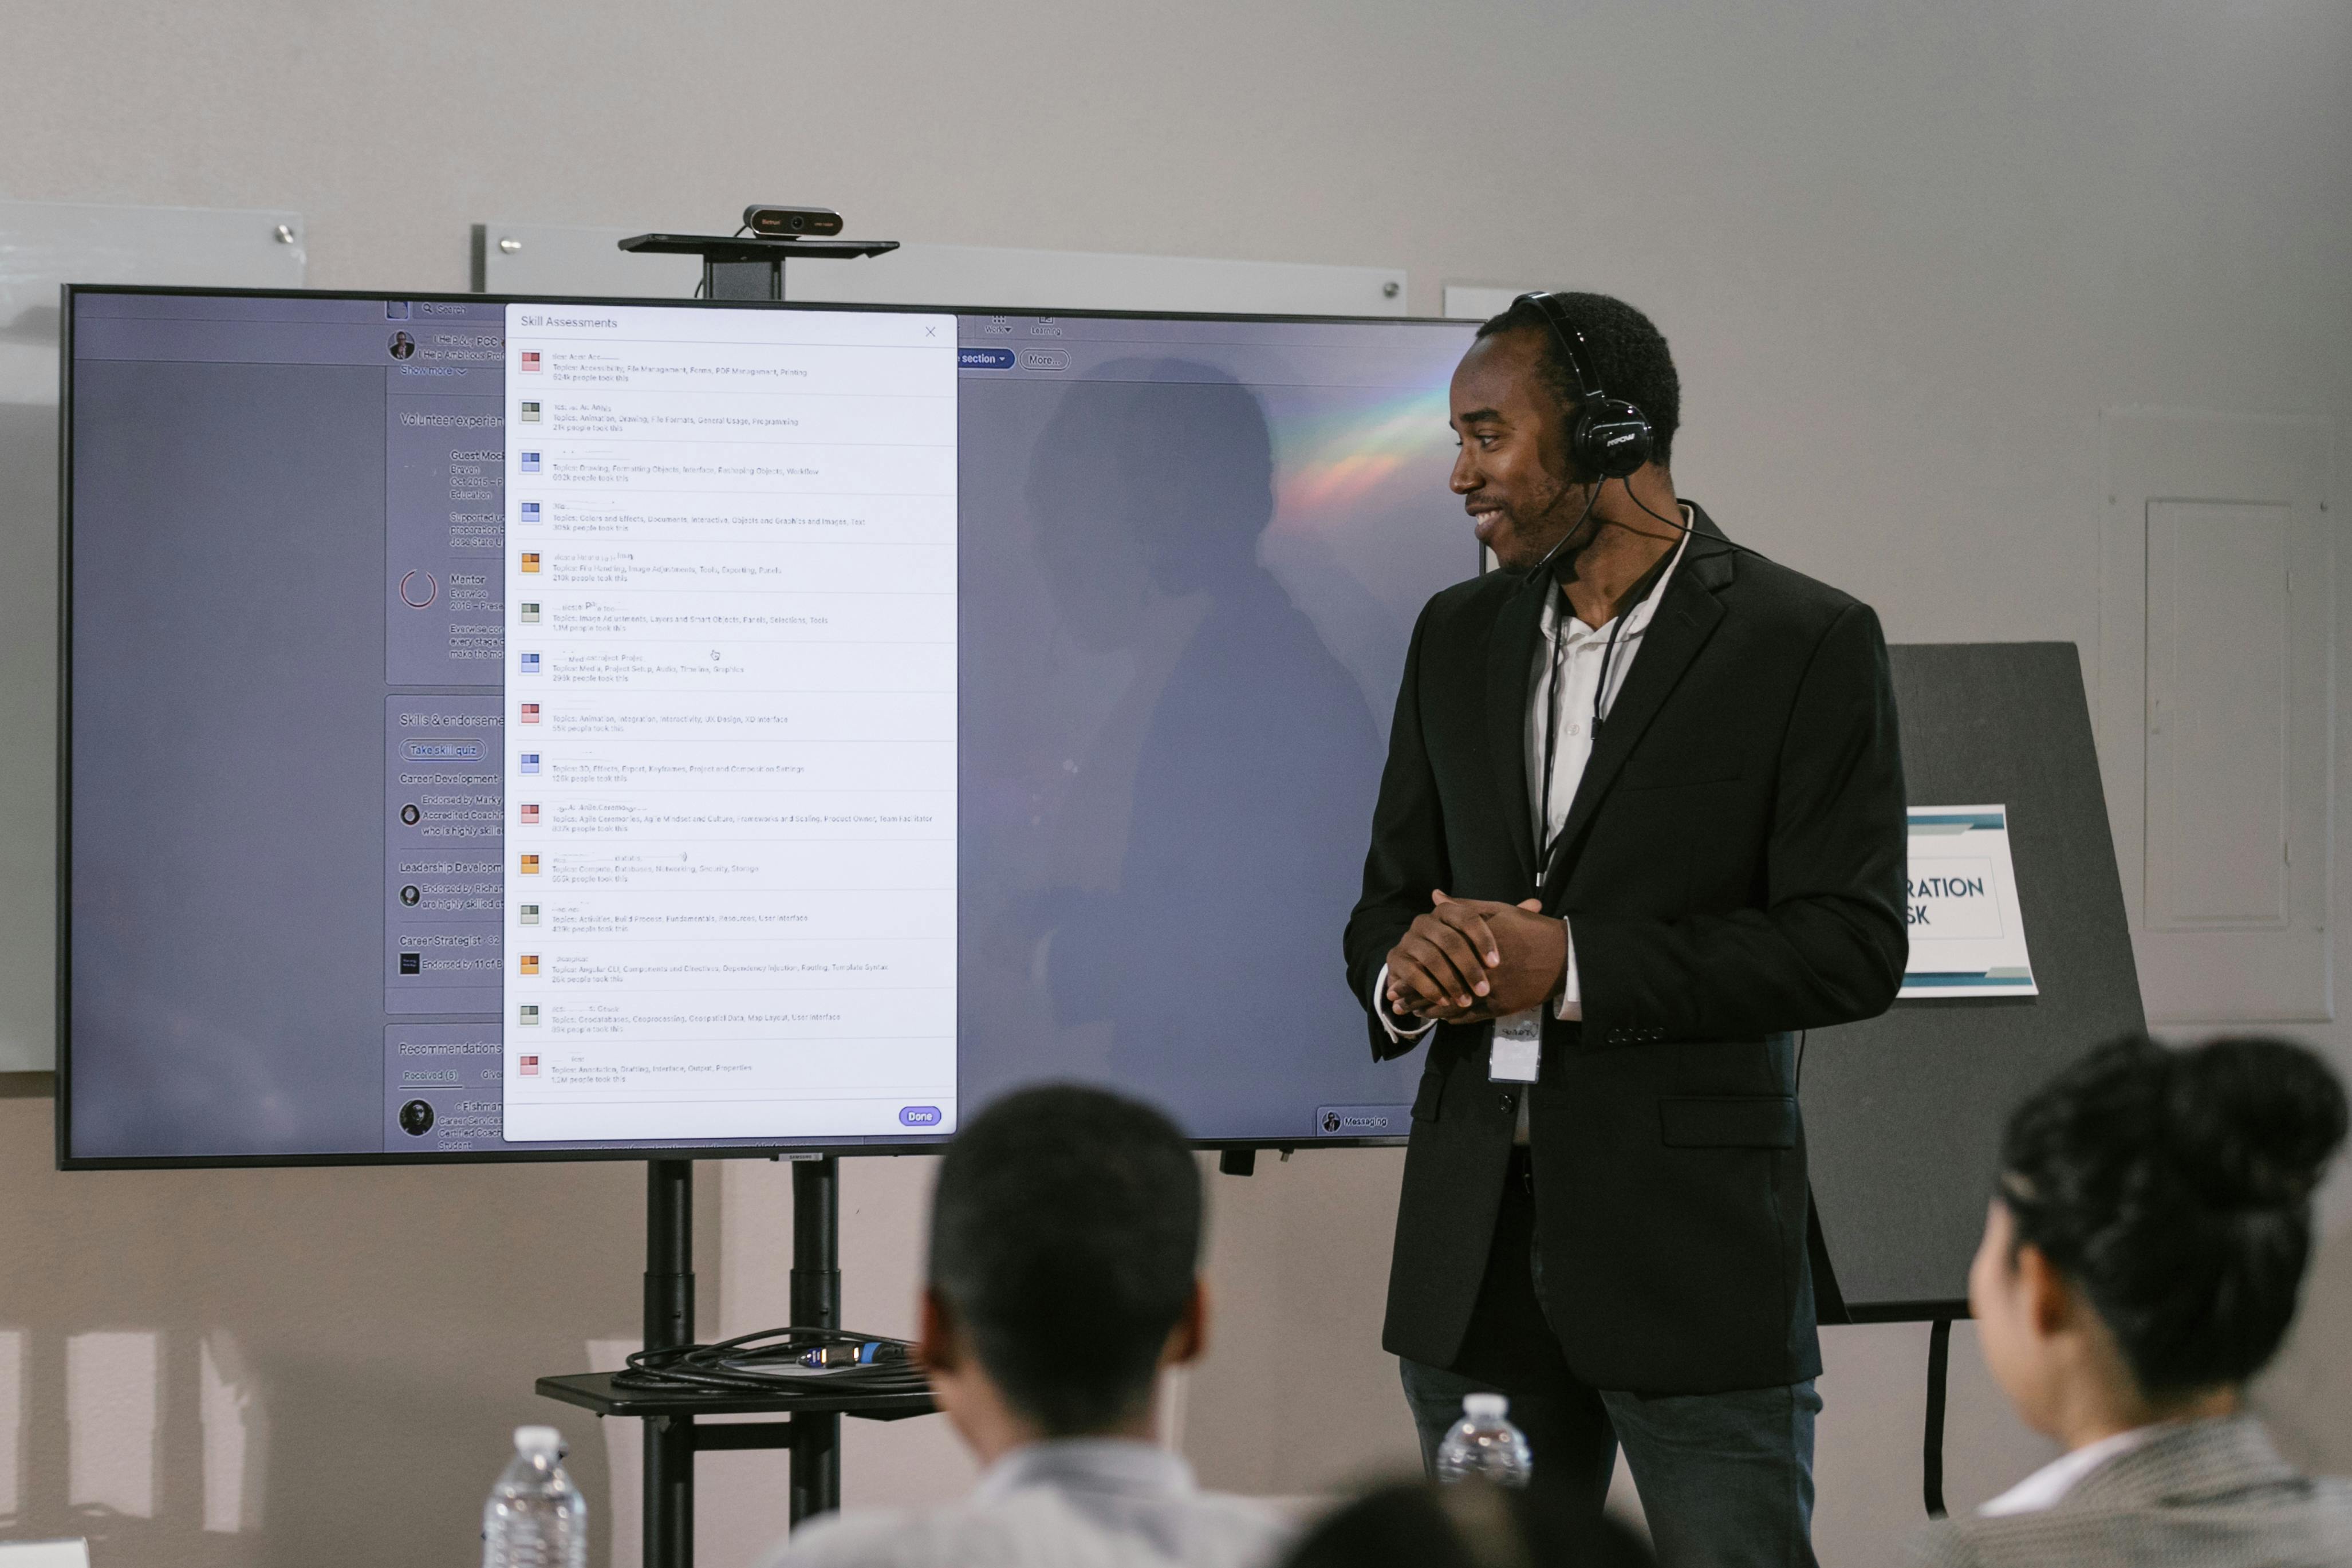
xmin=1371 ymin=508 xmax=1698 ymax=1067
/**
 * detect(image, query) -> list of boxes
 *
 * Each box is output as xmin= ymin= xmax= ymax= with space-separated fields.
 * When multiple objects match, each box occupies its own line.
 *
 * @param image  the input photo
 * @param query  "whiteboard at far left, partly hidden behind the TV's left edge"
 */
xmin=0 ymin=202 xmax=306 ymax=1072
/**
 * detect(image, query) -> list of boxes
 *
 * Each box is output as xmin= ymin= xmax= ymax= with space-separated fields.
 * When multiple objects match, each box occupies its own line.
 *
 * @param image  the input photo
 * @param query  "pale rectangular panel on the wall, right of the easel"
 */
xmin=2098 ymin=409 xmax=2335 ymax=1023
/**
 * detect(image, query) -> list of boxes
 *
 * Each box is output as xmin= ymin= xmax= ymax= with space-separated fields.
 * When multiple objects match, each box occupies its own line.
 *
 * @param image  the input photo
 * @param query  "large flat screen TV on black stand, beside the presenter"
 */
xmin=59 ymin=287 xmax=1477 ymax=1166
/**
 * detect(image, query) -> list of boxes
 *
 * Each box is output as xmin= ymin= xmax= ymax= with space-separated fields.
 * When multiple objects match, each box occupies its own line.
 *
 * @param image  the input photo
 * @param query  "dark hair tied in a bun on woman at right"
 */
xmin=2002 ymin=1037 xmax=2345 ymax=1398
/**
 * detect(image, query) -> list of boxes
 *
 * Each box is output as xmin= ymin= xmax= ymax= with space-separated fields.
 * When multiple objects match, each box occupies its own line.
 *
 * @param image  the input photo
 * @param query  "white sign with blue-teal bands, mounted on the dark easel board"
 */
xmin=1900 ymin=806 xmax=2042 ymax=999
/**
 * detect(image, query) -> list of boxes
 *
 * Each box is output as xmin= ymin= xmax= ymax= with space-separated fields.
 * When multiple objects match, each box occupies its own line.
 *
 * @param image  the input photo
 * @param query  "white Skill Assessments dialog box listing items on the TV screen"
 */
xmin=501 ymin=306 xmax=958 ymax=1142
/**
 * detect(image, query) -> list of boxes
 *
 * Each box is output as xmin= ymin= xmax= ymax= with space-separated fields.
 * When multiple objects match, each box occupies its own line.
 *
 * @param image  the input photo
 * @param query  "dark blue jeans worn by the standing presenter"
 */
xmin=1402 ymin=1157 xmax=1821 ymax=1568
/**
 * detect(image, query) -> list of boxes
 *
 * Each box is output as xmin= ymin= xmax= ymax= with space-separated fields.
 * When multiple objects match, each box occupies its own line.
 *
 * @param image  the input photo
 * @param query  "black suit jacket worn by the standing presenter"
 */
xmin=1345 ymin=508 xmax=1908 ymax=1394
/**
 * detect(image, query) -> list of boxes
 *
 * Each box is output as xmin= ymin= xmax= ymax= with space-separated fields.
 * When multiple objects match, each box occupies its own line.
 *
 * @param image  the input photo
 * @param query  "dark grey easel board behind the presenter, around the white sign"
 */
xmin=1799 ymin=642 xmax=2145 ymax=1321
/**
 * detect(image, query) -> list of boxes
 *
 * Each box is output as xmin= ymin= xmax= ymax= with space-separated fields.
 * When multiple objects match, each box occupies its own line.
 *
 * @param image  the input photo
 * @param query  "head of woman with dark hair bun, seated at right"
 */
xmin=1969 ymin=1037 xmax=2345 ymax=1446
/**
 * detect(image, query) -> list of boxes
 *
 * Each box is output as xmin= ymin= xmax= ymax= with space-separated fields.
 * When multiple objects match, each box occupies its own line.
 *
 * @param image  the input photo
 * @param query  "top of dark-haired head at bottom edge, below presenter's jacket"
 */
xmin=1282 ymin=1481 xmax=1653 ymax=1568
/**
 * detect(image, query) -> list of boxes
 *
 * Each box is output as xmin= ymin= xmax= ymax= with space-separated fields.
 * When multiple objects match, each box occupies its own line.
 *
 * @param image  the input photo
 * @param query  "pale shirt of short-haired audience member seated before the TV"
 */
xmin=767 ymin=1439 xmax=1291 ymax=1568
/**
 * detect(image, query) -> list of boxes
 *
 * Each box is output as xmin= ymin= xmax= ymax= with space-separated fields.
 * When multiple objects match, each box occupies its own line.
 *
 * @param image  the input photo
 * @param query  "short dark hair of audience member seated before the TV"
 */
xmin=929 ymin=1084 xmax=1202 ymax=1436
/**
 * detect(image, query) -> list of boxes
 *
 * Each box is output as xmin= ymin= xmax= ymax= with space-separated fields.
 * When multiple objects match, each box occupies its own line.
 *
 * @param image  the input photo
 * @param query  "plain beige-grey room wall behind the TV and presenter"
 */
xmin=0 ymin=0 xmax=2352 ymax=1568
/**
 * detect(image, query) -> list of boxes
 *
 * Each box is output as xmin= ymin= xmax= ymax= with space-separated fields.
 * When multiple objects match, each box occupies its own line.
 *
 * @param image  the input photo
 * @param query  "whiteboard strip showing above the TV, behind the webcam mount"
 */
xmin=475 ymin=223 xmax=1407 ymax=315
